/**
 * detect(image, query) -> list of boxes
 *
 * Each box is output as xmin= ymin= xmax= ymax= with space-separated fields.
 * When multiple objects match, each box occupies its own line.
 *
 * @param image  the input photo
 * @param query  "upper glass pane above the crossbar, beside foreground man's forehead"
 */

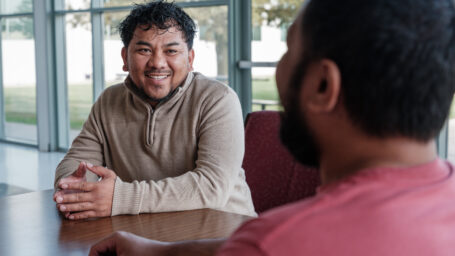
xmin=251 ymin=0 xmax=303 ymax=62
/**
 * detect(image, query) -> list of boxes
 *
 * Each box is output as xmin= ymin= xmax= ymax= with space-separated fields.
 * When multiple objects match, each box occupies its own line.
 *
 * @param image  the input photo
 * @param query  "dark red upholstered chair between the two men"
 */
xmin=243 ymin=111 xmax=320 ymax=213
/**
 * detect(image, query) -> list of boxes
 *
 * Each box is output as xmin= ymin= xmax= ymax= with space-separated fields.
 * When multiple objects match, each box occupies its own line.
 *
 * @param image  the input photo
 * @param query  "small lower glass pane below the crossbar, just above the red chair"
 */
xmin=251 ymin=68 xmax=281 ymax=111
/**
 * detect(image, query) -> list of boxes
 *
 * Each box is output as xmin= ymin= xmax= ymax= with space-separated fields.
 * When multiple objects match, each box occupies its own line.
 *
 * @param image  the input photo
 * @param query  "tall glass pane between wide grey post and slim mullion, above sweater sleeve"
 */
xmin=65 ymin=13 xmax=93 ymax=141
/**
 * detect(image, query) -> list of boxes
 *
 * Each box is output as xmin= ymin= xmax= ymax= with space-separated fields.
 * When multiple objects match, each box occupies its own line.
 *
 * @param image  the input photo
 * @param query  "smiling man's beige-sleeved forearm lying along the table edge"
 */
xmin=112 ymin=171 xmax=232 ymax=215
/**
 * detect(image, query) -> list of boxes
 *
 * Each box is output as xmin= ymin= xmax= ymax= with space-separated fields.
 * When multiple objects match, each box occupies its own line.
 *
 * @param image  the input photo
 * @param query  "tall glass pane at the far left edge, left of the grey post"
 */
xmin=1 ymin=17 xmax=37 ymax=143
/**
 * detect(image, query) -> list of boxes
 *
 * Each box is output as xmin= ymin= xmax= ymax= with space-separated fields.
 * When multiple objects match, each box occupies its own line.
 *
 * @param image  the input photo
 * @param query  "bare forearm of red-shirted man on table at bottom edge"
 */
xmin=163 ymin=238 xmax=226 ymax=256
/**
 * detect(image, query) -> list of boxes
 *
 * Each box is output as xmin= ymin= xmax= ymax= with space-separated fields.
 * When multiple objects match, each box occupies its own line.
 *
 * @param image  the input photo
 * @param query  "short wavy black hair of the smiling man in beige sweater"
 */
xmin=119 ymin=0 xmax=196 ymax=50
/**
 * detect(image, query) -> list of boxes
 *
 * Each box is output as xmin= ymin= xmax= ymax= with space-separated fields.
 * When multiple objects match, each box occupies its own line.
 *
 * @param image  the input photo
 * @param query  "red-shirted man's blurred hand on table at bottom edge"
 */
xmin=89 ymin=231 xmax=169 ymax=256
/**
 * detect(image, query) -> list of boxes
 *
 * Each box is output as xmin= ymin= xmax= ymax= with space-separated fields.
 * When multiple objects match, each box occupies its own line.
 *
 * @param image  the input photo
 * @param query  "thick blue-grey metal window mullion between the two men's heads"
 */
xmin=228 ymin=0 xmax=252 ymax=117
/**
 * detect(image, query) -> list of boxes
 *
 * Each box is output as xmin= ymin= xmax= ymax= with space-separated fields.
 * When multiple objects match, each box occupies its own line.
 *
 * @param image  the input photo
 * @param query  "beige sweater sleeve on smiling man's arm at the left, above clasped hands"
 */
xmin=54 ymin=100 xmax=104 ymax=189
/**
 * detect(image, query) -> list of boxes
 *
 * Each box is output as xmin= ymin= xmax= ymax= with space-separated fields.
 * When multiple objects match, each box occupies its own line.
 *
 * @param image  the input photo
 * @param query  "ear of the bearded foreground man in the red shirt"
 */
xmin=300 ymin=59 xmax=341 ymax=113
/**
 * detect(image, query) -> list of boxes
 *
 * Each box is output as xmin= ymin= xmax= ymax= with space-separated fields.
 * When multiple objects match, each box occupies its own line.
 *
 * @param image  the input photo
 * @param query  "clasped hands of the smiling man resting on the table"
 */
xmin=54 ymin=162 xmax=117 ymax=220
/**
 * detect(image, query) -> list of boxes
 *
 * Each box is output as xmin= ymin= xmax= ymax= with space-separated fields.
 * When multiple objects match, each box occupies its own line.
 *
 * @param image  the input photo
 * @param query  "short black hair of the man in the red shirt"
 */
xmin=299 ymin=0 xmax=455 ymax=142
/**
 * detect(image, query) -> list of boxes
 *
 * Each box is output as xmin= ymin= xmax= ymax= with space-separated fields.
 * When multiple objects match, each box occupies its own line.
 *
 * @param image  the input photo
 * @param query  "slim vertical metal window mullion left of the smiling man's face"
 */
xmin=91 ymin=0 xmax=104 ymax=102
